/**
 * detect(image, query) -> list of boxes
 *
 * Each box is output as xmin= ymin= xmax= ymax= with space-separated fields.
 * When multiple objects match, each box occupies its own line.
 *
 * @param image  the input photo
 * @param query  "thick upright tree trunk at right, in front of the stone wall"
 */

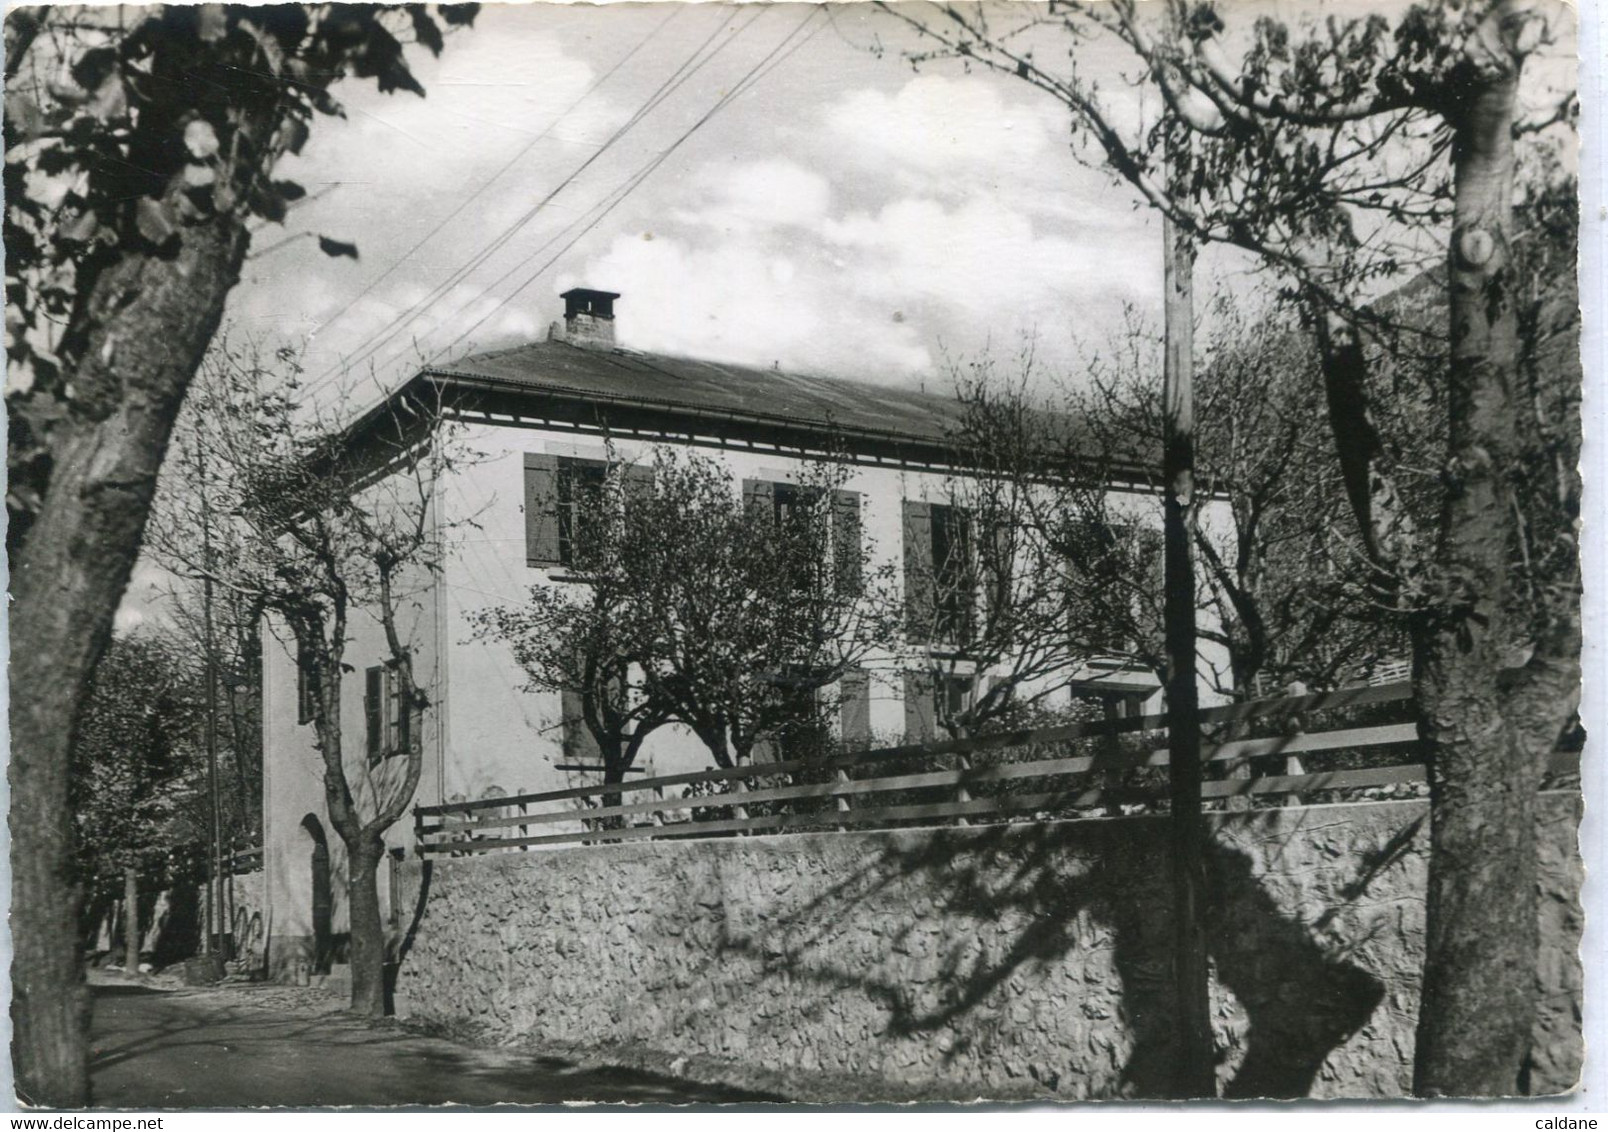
xmin=1413 ymin=59 xmax=1542 ymax=1097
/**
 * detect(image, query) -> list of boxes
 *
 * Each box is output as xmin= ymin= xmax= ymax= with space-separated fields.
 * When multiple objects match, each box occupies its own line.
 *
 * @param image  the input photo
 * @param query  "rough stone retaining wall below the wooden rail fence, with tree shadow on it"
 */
xmin=397 ymin=794 xmax=1582 ymax=1098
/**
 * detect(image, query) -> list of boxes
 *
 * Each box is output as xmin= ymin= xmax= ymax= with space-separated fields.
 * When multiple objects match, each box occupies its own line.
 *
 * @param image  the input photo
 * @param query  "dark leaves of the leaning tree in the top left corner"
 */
xmin=5 ymin=3 xmax=476 ymax=548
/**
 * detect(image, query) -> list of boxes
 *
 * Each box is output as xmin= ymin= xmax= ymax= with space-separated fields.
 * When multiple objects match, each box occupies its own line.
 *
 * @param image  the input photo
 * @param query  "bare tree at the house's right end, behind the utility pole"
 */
xmin=1068 ymin=299 xmax=1405 ymax=698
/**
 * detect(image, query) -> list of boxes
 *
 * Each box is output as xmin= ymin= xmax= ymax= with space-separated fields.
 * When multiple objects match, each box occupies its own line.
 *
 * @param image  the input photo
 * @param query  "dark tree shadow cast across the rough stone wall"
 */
xmin=725 ymin=822 xmax=1384 ymax=1098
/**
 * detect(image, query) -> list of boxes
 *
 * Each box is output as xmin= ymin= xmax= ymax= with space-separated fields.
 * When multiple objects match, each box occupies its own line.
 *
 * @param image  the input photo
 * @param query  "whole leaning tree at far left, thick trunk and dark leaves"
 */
xmin=5 ymin=5 xmax=476 ymax=1105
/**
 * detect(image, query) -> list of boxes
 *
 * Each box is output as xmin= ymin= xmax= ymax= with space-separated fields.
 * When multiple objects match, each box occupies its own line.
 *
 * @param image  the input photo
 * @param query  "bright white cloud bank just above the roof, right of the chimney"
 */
xmin=572 ymin=168 xmax=1159 ymax=383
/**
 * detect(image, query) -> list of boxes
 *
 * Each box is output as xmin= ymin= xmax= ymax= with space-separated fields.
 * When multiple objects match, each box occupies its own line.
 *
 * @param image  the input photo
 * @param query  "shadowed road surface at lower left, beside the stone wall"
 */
xmin=90 ymin=984 xmax=780 ymax=1108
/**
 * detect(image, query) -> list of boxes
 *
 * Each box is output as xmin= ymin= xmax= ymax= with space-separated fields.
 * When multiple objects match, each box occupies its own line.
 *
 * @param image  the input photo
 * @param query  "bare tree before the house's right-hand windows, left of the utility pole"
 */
xmin=904 ymin=353 xmax=1159 ymax=736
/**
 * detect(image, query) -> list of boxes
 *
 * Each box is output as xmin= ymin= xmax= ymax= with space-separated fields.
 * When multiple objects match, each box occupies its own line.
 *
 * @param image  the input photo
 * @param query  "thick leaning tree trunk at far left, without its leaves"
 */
xmin=10 ymin=212 xmax=246 ymax=1106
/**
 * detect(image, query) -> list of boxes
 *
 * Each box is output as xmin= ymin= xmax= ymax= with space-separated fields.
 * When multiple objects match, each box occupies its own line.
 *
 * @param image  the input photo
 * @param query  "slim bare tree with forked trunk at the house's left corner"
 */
xmin=151 ymin=341 xmax=468 ymax=1015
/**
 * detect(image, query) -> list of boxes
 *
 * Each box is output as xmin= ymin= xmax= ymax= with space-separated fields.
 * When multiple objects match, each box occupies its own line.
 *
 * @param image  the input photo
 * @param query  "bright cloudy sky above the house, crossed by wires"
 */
xmin=119 ymin=0 xmax=1573 ymax=629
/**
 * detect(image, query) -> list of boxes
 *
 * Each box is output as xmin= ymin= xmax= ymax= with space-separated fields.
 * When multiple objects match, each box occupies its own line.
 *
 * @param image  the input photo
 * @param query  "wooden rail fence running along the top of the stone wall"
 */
xmin=413 ymin=683 xmax=1579 ymax=855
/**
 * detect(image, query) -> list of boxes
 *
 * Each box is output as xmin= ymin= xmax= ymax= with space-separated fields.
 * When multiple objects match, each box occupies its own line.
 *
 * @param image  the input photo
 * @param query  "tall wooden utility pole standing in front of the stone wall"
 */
xmin=1161 ymin=125 xmax=1217 ymax=1098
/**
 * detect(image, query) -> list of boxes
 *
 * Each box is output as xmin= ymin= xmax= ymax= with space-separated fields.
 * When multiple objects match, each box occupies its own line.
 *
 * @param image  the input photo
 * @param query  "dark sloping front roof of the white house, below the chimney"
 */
xmin=426 ymin=341 xmax=962 ymax=444
